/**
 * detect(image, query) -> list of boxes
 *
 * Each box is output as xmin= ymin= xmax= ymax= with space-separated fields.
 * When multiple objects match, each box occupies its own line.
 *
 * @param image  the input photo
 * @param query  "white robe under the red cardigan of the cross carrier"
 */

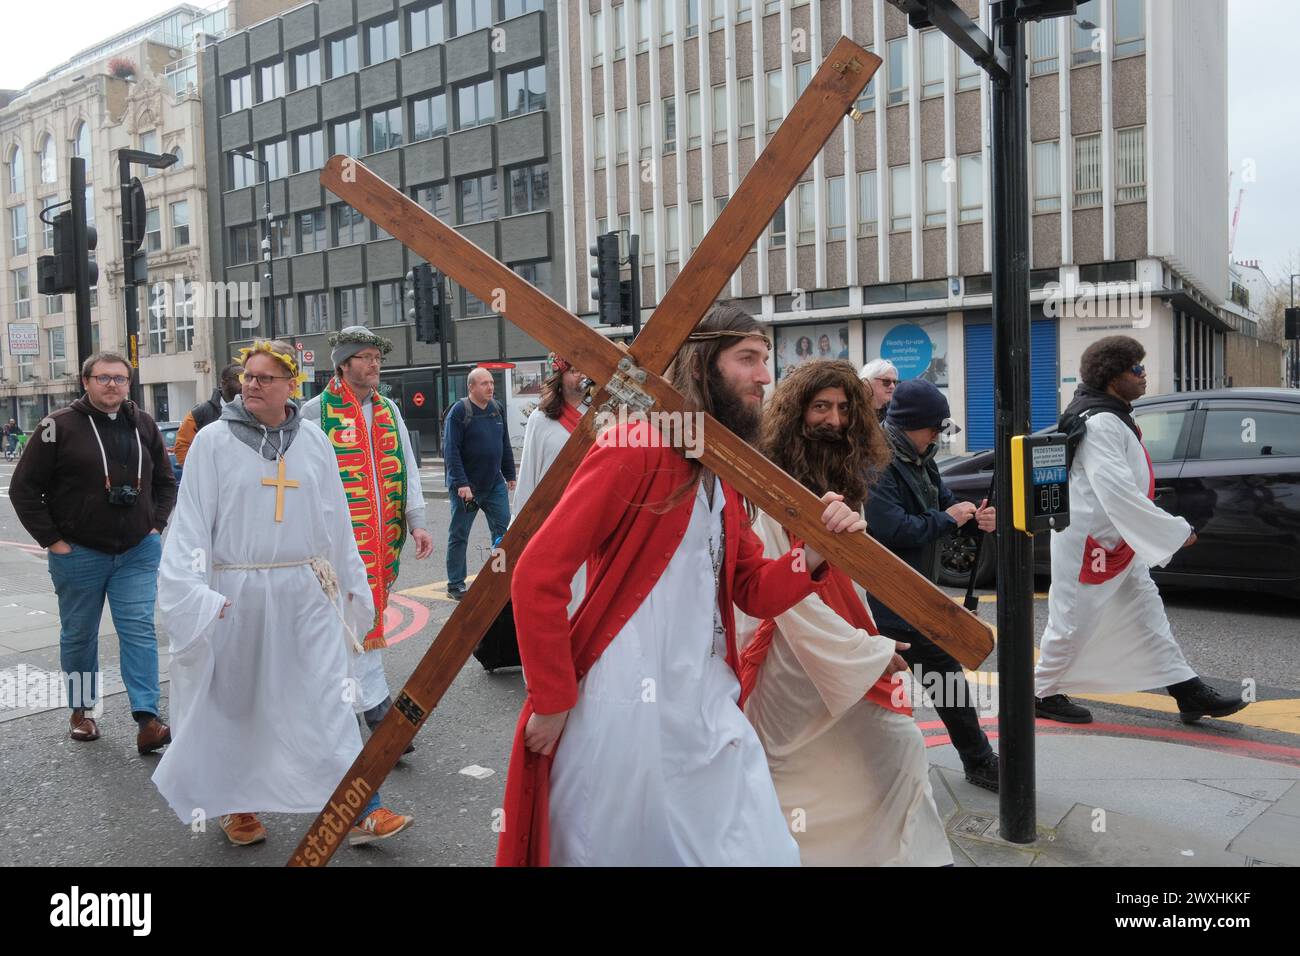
xmin=550 ymin=484 xmax=800 ymax=866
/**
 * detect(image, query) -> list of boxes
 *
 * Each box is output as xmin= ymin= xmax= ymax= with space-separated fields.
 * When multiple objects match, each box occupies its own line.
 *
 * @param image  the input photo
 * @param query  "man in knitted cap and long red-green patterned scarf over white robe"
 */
xmin=303 ymin=325 xmax=433 ymax=753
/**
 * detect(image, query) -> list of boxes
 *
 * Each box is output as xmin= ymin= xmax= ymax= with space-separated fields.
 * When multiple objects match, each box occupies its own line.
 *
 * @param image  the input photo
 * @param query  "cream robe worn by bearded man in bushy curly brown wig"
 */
xmin=736 ymin=514 xmax=953 ymax=866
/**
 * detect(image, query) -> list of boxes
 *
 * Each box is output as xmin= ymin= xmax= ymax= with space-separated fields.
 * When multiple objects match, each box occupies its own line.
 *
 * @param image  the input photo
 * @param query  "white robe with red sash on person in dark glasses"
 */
xmin=1034 ymin=412 xmax=1196 ymax=697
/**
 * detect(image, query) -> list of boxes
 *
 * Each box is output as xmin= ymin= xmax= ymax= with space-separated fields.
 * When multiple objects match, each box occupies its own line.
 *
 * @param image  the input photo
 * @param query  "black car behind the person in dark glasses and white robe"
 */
xmin=937 ymin=388 xmax=1300 ymax=598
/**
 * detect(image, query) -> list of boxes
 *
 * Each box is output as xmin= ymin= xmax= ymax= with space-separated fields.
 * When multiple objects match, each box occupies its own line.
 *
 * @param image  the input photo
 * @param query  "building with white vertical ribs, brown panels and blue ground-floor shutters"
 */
xmin=556 ymin=0 xmax=1232 ymax=450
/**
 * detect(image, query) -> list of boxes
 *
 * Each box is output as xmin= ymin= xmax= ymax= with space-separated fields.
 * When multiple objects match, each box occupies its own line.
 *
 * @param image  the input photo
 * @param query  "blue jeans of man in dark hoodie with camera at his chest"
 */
xmin=49 ymin=535 xmax=163 ymax=714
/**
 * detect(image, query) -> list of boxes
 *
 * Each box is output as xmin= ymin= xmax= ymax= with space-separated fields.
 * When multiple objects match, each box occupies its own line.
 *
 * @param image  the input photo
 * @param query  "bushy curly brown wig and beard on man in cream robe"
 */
xmin=758 ymin=360 xmax=889 ymax=510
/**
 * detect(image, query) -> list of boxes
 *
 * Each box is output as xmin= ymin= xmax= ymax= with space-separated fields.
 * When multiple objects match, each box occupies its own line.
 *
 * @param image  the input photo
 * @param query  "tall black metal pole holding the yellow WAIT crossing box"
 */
xmin=991 ymin=0 xmax=1037 ymax=843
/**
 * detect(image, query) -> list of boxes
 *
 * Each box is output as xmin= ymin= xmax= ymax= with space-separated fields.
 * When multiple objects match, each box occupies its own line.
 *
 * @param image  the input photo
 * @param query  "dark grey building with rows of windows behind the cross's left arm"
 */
xmin=204 ymin=0 xmax=566 ymax=449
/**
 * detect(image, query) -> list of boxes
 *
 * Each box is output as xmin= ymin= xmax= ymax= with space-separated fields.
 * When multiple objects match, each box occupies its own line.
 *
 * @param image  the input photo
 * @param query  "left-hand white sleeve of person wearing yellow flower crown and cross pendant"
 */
xmin=157 ymin=425 xmax=226 ymax=656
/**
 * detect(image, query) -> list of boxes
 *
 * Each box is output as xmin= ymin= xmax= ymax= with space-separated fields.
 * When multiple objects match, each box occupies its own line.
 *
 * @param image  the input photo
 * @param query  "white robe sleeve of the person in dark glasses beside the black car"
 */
xmin=1076 ymin=415 xmax=1192 ymax=567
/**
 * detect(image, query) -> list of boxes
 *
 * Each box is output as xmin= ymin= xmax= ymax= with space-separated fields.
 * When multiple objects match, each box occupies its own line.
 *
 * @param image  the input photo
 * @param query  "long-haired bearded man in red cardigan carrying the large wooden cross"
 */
xmin=497 ymin=306 xmax=866 ymax=865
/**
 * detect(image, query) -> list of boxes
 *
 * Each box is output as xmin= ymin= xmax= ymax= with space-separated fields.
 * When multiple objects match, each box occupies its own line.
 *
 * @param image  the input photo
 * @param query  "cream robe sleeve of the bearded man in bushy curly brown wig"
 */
xmin=754 ymin=514 xmax=894 ymax=717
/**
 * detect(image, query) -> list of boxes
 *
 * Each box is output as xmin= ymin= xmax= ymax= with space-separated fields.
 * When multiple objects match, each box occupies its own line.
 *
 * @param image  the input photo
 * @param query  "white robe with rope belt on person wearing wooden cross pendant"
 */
xmin=153 ymin=421 xmax=374 ymax=823
